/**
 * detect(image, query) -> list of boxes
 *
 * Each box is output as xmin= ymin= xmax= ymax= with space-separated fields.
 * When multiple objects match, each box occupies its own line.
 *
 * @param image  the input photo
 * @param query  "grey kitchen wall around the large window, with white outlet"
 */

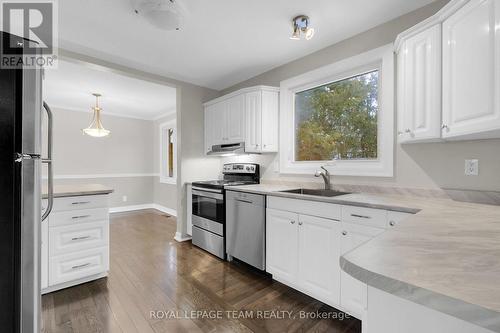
xmin=222 ymin=0 xmax=500 ymax=190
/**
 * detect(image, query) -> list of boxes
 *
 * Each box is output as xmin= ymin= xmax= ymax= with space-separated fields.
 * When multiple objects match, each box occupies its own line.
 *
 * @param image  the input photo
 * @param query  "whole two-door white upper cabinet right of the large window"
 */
xmin=396 ymin=0 xmax=500 ymax=143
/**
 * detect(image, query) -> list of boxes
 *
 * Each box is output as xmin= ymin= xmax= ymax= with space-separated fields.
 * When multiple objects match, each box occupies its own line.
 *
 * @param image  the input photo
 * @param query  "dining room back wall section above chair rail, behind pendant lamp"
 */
xmin=49 ymin=106 xmax=154 ymax=175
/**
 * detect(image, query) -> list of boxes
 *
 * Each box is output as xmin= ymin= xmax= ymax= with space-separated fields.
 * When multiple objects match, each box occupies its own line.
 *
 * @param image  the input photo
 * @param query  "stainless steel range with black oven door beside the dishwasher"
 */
xmin=192 ymin=163 xmax=260 ymax=259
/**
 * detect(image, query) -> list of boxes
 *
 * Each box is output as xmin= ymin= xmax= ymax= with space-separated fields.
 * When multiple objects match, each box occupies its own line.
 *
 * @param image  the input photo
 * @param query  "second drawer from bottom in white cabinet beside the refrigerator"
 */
xmin=49 ymin=221 xmax=109 ymax=256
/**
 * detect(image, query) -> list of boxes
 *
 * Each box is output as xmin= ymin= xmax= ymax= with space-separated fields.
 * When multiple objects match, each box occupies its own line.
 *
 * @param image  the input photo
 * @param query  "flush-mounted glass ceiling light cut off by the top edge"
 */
xmin=134 ymin=0 xmax=187 ymax=31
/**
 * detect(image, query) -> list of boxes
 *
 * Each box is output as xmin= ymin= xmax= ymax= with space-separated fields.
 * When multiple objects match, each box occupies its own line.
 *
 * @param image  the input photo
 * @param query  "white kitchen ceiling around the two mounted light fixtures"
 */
xmin=59 ymin=0 xmax=433 ymax=90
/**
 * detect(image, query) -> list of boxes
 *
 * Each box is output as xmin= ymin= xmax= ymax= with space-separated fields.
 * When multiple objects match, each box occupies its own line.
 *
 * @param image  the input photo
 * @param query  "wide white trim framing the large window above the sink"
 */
xmin=279 ymin=44 xmax=394 ymax=177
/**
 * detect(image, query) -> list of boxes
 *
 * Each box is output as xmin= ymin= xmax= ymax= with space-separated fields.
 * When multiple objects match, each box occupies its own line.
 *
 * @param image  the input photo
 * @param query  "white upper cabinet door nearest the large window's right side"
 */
xmin=397 ymin=25 xmax=441 ymax=143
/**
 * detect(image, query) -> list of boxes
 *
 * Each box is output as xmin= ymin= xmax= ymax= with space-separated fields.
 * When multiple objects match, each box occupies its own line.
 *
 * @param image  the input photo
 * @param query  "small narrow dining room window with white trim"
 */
xmin=160 ymin=120 xmax=177 ymax=184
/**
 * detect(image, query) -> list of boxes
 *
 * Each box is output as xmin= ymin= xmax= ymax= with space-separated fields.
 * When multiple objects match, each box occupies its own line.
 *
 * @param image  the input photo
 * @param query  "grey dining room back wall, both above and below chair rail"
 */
xmin=44 ymin=107 xmax=154 ymax=207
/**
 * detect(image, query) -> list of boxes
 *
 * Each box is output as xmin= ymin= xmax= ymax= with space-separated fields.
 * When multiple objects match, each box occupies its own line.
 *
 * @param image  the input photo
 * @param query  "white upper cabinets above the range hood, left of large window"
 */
xmin=205 ymin=86 xmax=279 ymax=153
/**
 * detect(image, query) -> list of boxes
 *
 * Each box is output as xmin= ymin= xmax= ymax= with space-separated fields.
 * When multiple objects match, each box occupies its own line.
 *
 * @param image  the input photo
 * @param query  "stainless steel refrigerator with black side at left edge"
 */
xmin=0 ymin=32 xmax=52 ymax=333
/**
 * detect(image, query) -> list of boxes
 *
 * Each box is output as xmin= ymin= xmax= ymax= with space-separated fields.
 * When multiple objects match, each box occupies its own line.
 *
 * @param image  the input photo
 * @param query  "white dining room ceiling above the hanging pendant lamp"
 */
xmin=43 ymin=61 xmax=176 ymax=120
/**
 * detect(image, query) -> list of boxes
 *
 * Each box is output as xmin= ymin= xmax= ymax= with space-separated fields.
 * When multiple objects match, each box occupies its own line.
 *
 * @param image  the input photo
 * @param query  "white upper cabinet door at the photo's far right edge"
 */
xmin=442 ymin=0 xmax=500 ymax=139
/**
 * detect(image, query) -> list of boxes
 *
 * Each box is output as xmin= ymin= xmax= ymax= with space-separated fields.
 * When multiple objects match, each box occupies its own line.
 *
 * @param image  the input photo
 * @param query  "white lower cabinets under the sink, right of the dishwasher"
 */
xmin=266 ymin=196 xmax=411 ymax=327
